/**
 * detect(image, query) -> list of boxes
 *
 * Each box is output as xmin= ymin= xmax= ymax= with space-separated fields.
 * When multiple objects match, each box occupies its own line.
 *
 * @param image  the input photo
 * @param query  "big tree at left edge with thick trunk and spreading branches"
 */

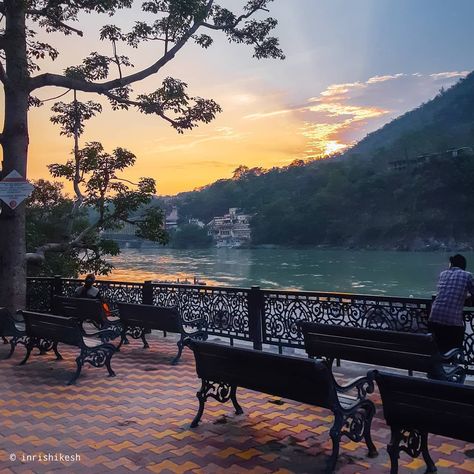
xmin=0 ymin=0 xmax=283 ymax=309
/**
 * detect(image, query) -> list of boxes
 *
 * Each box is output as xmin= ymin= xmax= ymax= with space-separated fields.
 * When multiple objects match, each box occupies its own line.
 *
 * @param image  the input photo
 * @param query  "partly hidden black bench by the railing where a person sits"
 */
xmin=52 ymin=296 xmax=122 ymax=338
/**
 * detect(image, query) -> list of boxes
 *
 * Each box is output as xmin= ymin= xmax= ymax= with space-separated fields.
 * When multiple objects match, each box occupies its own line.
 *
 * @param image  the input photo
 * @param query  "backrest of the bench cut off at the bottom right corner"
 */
xmin=375 ymin=371 xmax=474 ymax=443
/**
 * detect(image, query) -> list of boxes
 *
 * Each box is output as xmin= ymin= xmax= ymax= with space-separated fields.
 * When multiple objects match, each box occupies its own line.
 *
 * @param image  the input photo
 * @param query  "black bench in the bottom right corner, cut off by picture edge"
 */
xmin=369 ymin=370 xmax=474 ymax=474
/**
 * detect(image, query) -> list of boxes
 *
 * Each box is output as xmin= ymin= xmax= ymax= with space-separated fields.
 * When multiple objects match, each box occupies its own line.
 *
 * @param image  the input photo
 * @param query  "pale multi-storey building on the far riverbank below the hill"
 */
xmin=207 ymin=207 xmax=251 ymax=247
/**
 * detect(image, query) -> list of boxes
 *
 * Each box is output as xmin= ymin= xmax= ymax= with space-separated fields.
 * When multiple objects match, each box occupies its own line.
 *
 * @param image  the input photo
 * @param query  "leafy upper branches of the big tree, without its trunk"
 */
xmin=8 ymin=0 xmax=284 ymax=133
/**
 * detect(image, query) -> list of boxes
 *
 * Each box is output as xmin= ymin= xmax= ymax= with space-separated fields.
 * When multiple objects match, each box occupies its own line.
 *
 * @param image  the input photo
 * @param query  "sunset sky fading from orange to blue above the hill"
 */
xmin=12 ymin=0 xmax=474 ymax=195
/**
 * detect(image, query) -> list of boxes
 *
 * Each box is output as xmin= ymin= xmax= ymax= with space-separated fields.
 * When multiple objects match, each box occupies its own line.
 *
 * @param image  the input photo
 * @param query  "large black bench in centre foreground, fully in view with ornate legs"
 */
xmin=186 ymin=339 xmax=377 ymax=472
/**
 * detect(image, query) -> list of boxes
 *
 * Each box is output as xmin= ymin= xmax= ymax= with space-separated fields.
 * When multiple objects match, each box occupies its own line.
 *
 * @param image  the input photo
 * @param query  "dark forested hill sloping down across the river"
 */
xmin=172 ymin=74 xmax=474 ymax=249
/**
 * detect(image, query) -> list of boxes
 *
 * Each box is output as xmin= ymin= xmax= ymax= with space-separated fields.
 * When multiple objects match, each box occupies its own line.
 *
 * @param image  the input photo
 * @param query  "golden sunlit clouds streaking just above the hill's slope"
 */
xmin=245 ymin=71 xmax=468 ymax=159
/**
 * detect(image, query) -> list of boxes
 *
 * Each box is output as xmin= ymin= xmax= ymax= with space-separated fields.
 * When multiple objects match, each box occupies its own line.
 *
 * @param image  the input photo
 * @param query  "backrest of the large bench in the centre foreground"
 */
xmin=187 ymin=340 xmax=338 ymax=409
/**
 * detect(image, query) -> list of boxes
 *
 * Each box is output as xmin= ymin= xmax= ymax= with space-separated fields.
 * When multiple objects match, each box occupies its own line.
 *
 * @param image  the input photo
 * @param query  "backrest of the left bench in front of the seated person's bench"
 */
xmin=22 ymin=311 xmax=83 ymax=347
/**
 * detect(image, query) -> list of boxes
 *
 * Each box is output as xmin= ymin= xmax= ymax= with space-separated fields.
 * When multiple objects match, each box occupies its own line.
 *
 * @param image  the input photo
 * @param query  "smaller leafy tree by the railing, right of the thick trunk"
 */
xmin=26 ymin=91 xmax=168 ymax=275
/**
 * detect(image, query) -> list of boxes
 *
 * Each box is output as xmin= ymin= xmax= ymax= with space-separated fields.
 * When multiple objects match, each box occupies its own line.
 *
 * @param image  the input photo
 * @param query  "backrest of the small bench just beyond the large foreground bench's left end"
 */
xmin=117 ymin=302 xmax=182 ymax=333
